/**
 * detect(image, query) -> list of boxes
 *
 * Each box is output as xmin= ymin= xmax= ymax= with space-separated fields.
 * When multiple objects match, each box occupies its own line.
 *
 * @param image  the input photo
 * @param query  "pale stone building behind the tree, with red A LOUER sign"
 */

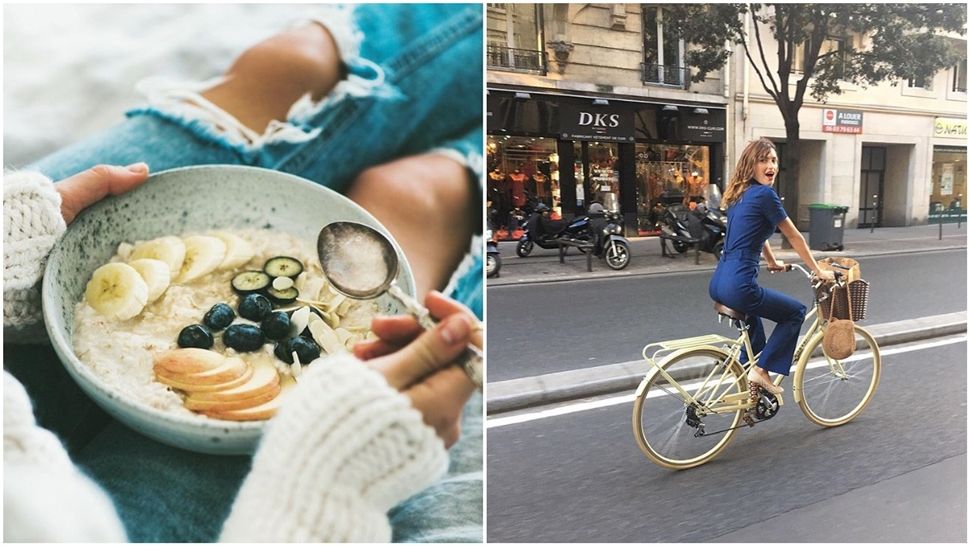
xmin=727 ymin=11 xmax=967 ymax=230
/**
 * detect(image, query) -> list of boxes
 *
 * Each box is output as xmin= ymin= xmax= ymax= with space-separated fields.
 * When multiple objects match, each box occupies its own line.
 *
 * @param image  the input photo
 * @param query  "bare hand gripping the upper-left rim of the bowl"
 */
xmin=54 ymin=163 xmax=148 ymax=224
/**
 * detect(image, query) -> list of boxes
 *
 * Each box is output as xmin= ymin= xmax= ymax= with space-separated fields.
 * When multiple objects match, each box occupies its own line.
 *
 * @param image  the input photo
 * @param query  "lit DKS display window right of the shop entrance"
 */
xmin=636 ymin=144 xmax=711 ymax=235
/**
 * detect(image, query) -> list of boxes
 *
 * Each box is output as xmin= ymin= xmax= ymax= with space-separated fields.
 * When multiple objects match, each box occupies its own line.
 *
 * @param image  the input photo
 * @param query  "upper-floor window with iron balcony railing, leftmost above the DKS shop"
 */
xmin=487 ymin=3 xmax=546 ymax=74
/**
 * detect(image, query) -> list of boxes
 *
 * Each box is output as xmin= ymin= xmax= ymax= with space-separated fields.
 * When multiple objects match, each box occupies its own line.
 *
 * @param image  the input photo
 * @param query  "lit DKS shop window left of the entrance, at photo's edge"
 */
xmin=486 ymin=135 xmax=562 ymax=238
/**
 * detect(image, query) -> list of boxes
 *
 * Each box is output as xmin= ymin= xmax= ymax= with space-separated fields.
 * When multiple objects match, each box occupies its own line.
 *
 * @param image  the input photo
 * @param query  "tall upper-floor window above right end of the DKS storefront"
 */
xmin=642 ymin=6 xmax=688 ymax=87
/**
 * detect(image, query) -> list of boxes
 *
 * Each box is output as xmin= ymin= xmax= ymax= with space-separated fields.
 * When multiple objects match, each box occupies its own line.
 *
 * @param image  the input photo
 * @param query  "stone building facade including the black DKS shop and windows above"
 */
xmin=486 ymin=4 xmax=730 ymax=235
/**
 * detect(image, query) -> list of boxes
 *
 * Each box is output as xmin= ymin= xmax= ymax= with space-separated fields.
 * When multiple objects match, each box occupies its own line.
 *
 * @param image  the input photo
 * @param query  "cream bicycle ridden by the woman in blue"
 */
xmin=633 ymin=265 xmax=882 ymax=470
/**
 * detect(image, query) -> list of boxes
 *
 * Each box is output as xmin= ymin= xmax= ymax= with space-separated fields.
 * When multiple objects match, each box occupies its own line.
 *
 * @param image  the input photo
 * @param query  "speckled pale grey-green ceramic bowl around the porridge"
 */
xmin=43 ymin=166 xmax=414 ymax=455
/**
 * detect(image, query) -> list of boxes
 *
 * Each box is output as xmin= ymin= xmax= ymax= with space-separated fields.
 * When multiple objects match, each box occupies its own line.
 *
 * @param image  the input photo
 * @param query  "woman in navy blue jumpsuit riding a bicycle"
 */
xmin=708 ymin=138 xmax=834 ymax=394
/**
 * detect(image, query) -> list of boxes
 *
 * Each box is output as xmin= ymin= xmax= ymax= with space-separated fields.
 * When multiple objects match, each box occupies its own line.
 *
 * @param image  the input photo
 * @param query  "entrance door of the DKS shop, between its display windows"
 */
xmin=573 ymin=141 xmax=620 ymax=213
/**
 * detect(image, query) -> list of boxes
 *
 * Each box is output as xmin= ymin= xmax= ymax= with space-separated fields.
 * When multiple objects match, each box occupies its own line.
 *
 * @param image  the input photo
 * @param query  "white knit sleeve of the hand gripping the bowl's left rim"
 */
xmin=3 ymin=172 xmax=67 ymax=342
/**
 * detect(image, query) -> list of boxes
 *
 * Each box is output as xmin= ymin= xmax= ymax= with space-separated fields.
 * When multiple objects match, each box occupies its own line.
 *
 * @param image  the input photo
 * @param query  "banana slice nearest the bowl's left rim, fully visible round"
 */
xmin=84 ymin=262 xmax=148 ymax=320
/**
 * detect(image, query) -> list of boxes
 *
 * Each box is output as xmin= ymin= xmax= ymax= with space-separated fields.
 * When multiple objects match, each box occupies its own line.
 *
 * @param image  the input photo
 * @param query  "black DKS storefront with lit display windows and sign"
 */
xmin=486 ymin=89 xmax=725 ymax=236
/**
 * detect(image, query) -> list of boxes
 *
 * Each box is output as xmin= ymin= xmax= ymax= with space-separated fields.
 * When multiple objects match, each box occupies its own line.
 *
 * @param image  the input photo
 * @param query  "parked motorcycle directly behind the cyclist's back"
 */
xmin=660 ymin=184 xmax=727 ymax=259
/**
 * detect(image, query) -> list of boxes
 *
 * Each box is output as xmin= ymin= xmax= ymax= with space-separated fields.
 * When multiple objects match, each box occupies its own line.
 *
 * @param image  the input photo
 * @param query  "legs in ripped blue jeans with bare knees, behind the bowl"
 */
xmin=4 ymin=4 xmax=483 ymax=542
